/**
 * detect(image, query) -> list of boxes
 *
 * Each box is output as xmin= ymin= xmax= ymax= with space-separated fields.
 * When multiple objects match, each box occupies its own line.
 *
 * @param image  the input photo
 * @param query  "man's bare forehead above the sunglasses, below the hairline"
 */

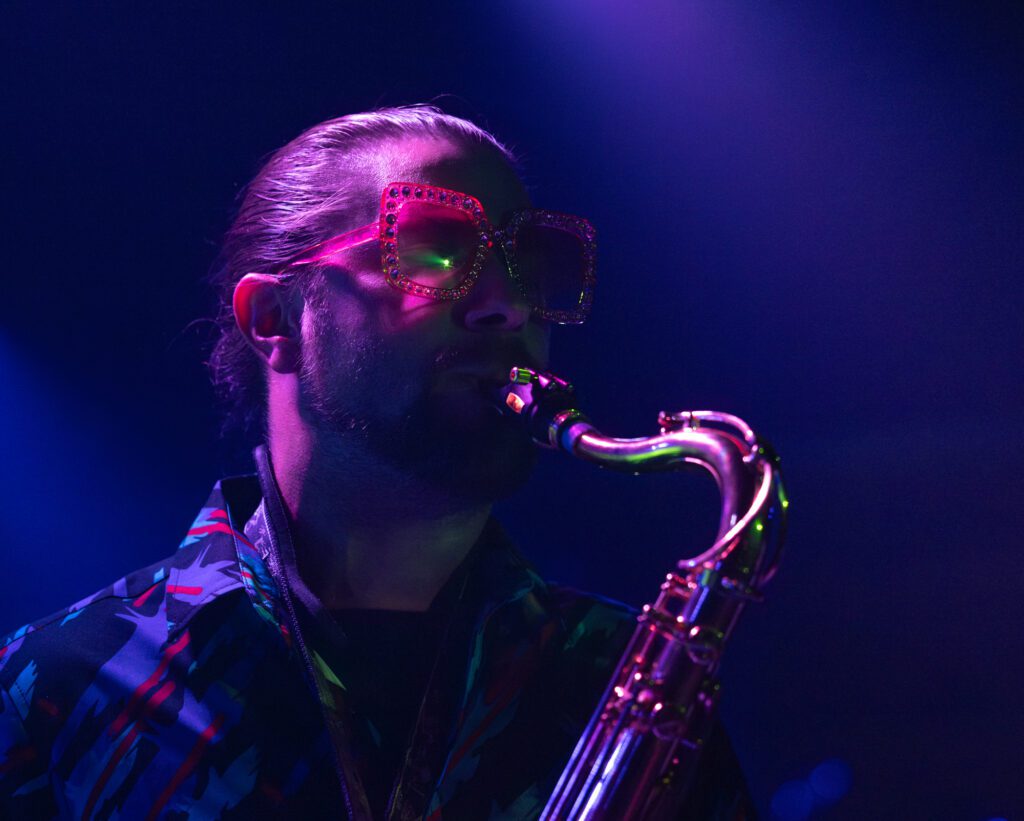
xmin=360 ymin=137 xmax=530 ymax=220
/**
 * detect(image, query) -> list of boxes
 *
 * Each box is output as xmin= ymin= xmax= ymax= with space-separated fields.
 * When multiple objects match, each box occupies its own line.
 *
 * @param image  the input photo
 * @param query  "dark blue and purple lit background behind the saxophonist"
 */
xmin=0 ymin=0 xmax=1024 ymax=821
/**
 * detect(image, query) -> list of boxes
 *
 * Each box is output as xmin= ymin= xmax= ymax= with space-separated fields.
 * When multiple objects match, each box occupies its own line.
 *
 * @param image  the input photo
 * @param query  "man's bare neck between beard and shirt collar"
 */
xmin=270 ymin=431 xmax=490 ymax=611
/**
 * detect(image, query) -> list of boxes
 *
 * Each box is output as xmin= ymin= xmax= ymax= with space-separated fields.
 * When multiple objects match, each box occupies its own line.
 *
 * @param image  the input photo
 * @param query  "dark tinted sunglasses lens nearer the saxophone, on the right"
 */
xmin=515 ymin=223 xmax=585 ymax=310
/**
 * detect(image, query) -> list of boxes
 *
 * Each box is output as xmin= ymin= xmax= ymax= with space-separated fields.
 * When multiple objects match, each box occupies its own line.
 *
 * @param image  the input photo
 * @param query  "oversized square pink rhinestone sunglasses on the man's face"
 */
xmin=273 ymin=182 xmax=597 ymax=325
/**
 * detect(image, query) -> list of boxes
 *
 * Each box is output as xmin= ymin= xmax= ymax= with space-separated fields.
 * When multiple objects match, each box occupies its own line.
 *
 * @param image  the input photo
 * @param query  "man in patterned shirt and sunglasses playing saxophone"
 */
xmin=0 ymin=106 xmax=753 ymax=820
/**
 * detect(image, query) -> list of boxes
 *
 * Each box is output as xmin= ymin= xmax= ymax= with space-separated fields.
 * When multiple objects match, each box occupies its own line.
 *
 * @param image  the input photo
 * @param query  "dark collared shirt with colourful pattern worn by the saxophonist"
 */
xmin=0 ymin=448 xmax=754 ymax=821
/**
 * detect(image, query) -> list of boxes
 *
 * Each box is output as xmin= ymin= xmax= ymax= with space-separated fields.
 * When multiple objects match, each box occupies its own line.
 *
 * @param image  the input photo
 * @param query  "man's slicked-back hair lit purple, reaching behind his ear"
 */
xmin=208 ymin=105 xmax=516 ymax=435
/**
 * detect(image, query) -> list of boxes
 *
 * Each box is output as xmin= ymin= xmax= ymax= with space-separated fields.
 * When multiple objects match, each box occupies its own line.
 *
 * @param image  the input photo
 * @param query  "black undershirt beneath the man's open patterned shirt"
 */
xmin=331 ymin=610 xmax=444 ymax=818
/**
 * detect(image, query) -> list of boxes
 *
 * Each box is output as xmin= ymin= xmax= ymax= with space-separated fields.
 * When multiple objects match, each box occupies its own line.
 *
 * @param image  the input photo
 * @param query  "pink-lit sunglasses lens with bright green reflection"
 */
xmin=398 ymin=202 xmax=479 ymax=288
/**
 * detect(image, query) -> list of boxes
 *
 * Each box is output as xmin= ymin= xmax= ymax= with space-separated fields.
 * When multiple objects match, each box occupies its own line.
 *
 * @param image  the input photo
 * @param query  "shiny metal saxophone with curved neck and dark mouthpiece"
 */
xmin=497 ymin=368 xmax=788 ymax=821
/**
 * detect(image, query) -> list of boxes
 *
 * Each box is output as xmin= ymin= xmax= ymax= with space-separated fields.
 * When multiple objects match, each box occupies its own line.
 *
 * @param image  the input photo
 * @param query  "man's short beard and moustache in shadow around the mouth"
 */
xmin=300 ymin=303 xmax=537 ymax=505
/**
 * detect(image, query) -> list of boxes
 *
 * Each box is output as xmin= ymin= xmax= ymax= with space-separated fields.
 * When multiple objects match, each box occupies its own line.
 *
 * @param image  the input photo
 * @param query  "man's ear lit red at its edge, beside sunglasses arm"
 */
xmin=231 ymin=273 xmax=302 ymax=374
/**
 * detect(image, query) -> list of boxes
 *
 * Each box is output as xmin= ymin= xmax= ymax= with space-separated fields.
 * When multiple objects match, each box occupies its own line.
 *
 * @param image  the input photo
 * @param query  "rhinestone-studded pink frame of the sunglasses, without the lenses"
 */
xmin=273 ymin=182 xmax=597 ymax=325
